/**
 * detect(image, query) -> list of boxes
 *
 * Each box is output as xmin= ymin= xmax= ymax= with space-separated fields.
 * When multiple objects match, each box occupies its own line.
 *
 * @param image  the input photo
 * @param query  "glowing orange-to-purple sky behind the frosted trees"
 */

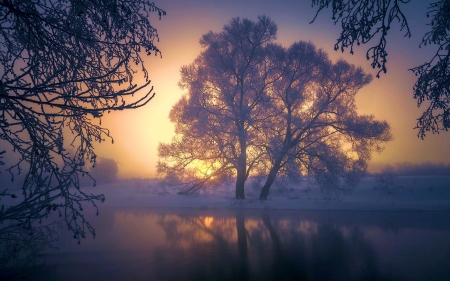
xmin=96 ymin=0 xmax=450 ymax=178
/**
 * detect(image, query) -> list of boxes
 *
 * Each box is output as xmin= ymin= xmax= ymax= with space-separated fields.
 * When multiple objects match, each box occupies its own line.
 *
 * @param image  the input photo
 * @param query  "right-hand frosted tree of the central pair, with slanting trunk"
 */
xmin=260 ymin=42 xmax=391 ymax=200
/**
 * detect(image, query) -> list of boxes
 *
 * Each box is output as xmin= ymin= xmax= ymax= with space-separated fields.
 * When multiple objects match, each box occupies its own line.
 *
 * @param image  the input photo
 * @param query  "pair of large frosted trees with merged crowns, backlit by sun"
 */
xmin=158 ymin=16 xmax=391 ymax=199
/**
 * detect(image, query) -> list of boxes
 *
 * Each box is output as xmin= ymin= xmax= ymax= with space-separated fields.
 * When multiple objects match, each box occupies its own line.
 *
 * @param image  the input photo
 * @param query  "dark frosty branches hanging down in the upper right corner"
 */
xmin=311 ymin=0 xmax=450 ymax=139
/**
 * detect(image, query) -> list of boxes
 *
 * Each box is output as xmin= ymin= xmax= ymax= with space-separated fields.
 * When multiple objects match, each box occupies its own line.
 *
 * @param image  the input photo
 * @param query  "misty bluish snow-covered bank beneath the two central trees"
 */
xmin=84 ymin=176 xmax=450 ymax=211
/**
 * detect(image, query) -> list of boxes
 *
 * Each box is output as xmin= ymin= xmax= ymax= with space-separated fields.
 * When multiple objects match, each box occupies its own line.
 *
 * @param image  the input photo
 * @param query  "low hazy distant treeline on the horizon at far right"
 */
xmin=372 ymin=163 xmax=450 ymax=176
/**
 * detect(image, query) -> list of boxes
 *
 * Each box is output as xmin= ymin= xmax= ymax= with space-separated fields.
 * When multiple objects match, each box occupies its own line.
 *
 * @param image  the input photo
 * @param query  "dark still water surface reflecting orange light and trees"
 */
xmin=3 ymin=208 xmax=450 ymax=281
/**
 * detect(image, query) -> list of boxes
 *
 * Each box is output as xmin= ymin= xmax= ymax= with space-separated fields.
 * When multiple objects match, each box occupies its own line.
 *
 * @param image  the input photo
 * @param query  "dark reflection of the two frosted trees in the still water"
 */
xmin=154 ymin=211 xmax=387 ymax=280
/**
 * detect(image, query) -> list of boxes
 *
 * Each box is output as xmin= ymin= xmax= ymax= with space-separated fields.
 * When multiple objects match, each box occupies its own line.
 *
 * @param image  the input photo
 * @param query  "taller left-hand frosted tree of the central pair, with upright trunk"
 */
xmin=158 ymin=16 xmax=280 ymax=199
